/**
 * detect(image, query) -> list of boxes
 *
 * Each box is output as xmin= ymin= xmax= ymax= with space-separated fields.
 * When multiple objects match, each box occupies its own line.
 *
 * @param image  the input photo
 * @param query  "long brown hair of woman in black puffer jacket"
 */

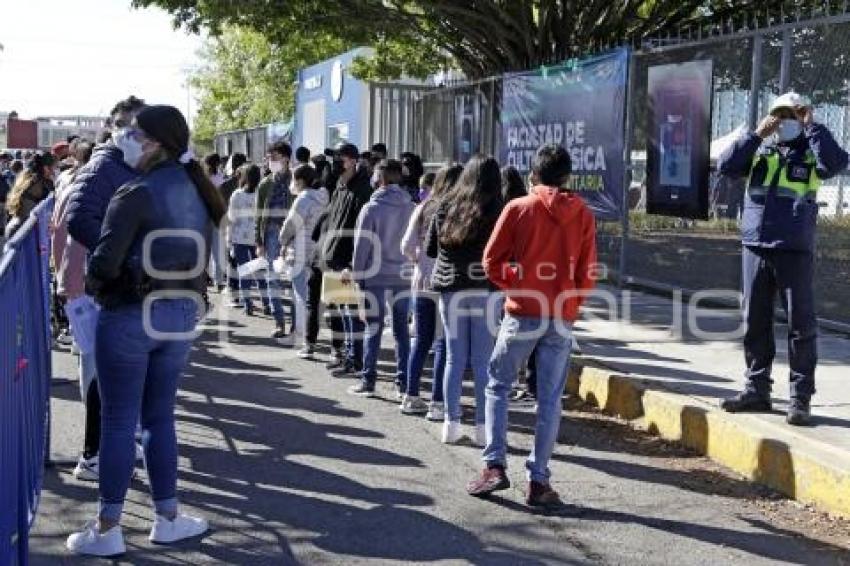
xmin=440 ymin=154 xmax=502 ymax=247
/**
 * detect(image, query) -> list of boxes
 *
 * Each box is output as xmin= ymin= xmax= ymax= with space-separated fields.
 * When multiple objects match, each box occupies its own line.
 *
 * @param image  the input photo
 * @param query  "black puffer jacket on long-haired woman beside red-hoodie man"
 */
xmin=425 ymin=202 xmax=501 ymax=292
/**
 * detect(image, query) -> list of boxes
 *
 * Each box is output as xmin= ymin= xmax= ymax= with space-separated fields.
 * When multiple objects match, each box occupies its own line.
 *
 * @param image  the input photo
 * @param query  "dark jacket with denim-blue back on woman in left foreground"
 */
xmin=86 ymin=162 xmax=213 ymax=309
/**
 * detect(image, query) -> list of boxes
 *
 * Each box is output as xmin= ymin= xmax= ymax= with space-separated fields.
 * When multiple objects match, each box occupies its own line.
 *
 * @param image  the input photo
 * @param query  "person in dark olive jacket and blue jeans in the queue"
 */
xmin=255 ymin=141 xmax=294 ymax=347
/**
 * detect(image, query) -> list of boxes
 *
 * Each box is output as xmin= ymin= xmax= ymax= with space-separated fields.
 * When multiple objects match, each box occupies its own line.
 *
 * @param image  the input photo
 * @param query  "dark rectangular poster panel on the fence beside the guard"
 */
xmin=646 ymin=60 xmax=712 ymax=219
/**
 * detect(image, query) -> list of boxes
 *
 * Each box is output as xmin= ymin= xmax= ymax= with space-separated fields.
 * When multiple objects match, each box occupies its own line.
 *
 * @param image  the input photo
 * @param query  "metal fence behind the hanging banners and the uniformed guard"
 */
xmin=380 ymin=6 xmax=850 ymax=328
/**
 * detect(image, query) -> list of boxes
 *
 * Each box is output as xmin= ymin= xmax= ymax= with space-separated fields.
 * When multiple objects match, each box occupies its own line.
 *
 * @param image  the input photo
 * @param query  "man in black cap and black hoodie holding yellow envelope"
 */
xmin=317 ymin=144 xmax=372 ymax=377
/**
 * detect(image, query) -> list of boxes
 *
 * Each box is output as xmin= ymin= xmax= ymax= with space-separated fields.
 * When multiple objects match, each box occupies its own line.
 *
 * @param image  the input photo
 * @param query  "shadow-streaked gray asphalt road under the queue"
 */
xmin=30 ymin=300 xmax=850 ymax=566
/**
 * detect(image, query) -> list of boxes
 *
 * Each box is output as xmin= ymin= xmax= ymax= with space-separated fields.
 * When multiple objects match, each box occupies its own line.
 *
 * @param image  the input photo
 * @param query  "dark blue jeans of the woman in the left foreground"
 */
xmin=95 ymin=299 xmax=197 ymax=521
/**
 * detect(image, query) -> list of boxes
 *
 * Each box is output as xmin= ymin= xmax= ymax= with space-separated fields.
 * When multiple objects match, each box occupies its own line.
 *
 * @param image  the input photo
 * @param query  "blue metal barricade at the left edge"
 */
xmin=0 ymin=198 xmax=53 ymax=566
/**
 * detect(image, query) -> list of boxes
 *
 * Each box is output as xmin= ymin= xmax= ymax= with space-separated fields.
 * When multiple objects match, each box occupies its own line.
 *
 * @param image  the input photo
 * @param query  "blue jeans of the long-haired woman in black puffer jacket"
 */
xmin=440 ymin=289 xmax=500 ymax=424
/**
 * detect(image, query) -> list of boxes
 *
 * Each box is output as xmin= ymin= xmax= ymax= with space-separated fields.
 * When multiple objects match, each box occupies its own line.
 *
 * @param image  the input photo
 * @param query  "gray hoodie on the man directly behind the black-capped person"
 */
xmin=352 ymin=185 xmax=415 ymax=288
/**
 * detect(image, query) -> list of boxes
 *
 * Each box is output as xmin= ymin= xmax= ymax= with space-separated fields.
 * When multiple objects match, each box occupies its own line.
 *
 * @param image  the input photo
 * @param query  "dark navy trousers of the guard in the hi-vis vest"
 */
xmin=742 ymin=246 xmax=817 ymax=400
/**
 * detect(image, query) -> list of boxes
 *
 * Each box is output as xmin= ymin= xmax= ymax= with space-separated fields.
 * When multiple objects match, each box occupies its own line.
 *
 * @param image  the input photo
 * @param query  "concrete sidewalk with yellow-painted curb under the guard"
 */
xmin=574 ymin=287 xmax=850 ymax=515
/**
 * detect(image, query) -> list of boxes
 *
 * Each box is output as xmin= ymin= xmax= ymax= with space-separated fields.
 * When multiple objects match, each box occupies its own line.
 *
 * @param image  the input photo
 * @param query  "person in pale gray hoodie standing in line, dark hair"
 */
xmin=280 ymin=162 xmax=330 ymax=358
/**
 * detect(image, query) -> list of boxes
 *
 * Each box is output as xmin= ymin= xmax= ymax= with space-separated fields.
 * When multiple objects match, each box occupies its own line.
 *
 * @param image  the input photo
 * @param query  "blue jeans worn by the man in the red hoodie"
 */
xmin=483 ymin=314 xmax=572 ymax=483
